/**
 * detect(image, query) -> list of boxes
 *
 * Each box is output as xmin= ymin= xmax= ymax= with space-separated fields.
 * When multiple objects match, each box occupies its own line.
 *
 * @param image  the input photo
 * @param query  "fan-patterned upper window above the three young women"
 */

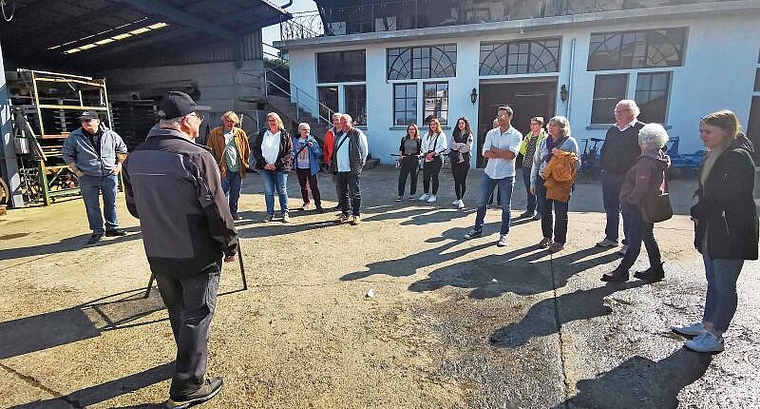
xmin=387 ymin=44 xmax=457 ymax=80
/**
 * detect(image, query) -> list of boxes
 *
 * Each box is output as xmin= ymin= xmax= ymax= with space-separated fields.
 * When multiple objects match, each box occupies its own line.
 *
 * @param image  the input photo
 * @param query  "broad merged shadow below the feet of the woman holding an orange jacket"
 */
xmin=409 ymin=245 xmax=619 ymax=299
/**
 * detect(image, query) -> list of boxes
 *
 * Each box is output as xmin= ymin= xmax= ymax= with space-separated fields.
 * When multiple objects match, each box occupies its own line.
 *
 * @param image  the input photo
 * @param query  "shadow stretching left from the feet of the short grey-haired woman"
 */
xmin=489 ymin=281 xmax=647 ymax=348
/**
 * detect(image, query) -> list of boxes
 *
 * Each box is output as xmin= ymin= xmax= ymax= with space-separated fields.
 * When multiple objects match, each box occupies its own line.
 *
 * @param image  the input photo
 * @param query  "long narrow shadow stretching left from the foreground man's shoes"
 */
xmin=10 ymin=362 xmax=174 ymax=409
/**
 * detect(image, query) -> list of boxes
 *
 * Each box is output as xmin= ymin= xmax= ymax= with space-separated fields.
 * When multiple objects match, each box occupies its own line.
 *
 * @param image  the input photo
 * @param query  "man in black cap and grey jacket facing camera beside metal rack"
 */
xmin=62 ymin=111 xmax=127 ymax=244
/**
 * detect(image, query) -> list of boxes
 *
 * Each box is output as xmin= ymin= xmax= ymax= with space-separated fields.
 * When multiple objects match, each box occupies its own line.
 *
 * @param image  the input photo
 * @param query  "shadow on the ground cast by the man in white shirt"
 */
xmin=340 ymin=228 xmax=502 ymax=281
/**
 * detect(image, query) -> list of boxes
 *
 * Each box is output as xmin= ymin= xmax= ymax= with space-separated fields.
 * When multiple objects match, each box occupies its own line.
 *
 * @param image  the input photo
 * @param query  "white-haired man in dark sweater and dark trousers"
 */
xmin=596 ymin=99 xmax=644 ymax=254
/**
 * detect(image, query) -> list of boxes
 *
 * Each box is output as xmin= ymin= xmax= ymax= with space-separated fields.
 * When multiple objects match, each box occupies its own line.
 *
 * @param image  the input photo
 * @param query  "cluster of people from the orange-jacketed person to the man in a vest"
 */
xmin=208 ymin=111 xmax=369 ymax=225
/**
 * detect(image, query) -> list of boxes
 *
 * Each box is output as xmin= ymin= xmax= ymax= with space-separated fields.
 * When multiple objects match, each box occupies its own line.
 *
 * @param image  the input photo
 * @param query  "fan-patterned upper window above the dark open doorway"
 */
xmin=480 ymin=38 xmax=560 ymax=75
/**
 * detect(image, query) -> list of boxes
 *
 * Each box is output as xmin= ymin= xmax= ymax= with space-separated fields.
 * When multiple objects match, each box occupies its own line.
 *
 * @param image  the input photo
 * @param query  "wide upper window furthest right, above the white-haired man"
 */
xmin=588 ymin=27 xmax=687 ymax=71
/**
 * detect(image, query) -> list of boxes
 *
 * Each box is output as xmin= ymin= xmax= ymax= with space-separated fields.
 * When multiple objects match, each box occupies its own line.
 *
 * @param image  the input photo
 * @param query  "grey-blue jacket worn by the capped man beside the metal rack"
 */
xmin=62 ymin=125 xmax=127 ymax=177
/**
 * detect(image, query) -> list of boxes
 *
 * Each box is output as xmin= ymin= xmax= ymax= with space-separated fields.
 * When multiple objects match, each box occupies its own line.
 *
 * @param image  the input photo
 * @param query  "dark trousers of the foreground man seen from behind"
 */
xmin=154 ymin=260 xmax=221 ymax=397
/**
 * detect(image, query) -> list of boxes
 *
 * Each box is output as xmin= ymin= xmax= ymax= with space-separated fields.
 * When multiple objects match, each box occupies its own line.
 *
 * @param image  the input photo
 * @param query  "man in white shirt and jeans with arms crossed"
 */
xmin=464 ymin=105 xmax=522 ymax=247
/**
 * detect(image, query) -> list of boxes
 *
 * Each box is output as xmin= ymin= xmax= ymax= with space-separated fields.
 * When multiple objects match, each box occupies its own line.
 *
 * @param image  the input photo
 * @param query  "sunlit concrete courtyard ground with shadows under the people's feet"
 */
xmin=0 ymin=166 xmax=760 ymax=409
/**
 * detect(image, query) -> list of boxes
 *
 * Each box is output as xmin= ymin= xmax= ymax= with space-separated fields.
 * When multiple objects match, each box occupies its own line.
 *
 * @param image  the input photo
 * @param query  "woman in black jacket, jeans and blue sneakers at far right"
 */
xmin=672 ymin=110 xmax=758 ymax=352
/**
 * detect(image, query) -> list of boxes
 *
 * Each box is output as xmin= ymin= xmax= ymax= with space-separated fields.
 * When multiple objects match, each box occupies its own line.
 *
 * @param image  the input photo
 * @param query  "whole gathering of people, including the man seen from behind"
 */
xmin=64 ymin=86 xmax=758 ymax=408
